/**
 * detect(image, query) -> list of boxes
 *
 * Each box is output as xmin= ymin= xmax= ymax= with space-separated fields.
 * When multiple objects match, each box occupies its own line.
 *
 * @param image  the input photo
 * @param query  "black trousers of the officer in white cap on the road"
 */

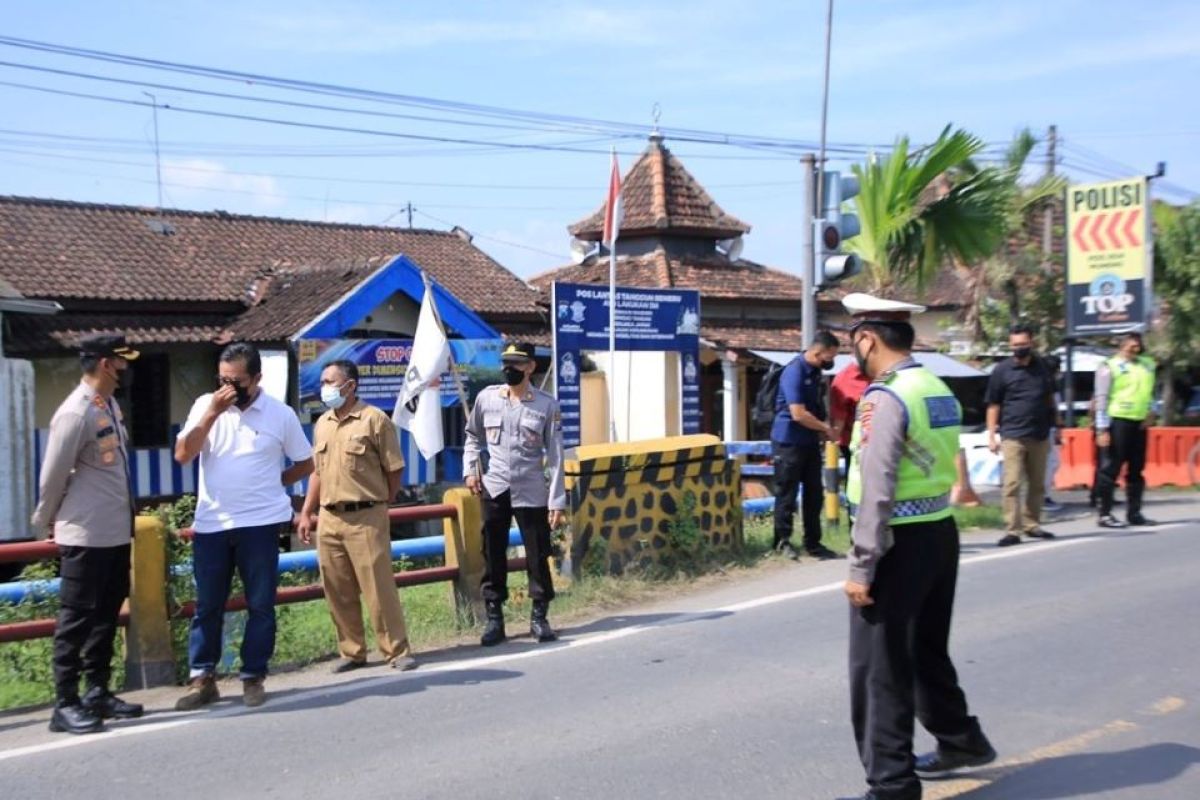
xmin=850 ymin=518 xmax=986 ymax=800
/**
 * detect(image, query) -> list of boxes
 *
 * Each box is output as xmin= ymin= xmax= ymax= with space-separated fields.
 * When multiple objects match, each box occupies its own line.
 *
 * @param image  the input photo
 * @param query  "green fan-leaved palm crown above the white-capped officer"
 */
xmin=846 ymin=126 xmax=1009 ymax=290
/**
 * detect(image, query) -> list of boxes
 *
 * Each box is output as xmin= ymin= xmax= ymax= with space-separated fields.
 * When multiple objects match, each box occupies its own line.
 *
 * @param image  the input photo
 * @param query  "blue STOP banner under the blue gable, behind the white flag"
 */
xmin=296 ymin=339 xmax=504 ymax=414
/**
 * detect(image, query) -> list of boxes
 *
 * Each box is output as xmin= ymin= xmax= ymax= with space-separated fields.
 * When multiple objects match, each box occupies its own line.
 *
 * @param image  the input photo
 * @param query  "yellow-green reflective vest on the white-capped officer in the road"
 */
xmin=846 ymin=367 xmax=962 ymax=525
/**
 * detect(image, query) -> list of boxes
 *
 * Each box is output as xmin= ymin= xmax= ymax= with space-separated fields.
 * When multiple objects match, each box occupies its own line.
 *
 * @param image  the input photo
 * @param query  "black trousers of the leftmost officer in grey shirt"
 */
xmin=54 ymin=545 xmax=130 ymax=705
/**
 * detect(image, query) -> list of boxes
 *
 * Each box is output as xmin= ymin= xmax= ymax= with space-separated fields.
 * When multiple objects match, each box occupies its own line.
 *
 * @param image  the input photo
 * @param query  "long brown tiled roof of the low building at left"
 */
xmin=0 ymin=197 xmax=538 ymax=315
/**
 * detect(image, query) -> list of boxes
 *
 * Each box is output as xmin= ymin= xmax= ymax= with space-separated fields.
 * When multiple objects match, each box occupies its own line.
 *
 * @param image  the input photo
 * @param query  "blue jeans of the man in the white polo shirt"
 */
xmin=187 ymin=523 xmax=282 ymax=680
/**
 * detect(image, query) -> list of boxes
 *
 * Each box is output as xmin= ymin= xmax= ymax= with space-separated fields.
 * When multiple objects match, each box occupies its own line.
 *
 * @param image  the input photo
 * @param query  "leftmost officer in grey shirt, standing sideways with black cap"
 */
xmin=32 ymin=335 xmax=142 ymax=734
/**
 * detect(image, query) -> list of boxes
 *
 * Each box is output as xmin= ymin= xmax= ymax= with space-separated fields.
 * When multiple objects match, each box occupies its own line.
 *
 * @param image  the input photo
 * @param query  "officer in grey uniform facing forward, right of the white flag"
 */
xmin=463 ymin=344 xmax=566 ymax=646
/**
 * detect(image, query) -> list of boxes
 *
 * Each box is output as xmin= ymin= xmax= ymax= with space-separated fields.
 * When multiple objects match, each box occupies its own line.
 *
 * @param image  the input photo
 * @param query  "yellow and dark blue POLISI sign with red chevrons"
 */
xmin=1067 ymin=176 xmax=1152 ymax=336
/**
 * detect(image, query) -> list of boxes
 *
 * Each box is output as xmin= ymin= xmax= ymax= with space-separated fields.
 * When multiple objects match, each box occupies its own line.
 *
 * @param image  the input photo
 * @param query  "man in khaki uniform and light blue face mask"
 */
xmin=299 ymin=361 xmax=416 ymax=673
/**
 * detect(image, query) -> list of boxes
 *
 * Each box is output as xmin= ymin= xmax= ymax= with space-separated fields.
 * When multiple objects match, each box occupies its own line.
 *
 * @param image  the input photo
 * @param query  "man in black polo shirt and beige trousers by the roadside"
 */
xmin=986 ymin=325 xmax=1056 ymax=547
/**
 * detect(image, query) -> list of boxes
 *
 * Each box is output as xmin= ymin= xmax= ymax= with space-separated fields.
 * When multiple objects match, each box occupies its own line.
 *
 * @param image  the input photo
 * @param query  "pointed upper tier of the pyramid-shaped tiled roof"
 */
xmin=568 ymin=136 xmax=750 ymax=241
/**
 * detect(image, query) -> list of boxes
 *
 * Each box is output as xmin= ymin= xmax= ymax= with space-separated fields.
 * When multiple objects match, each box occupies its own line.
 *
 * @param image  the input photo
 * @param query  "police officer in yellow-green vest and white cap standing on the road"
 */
xmin=842 ymin=293 xmax=996 ymax=800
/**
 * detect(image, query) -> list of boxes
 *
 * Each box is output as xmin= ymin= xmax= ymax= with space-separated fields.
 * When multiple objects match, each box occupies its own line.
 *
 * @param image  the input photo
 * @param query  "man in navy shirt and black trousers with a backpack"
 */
xmin=770 ymin=331 xmax=839 ymax=559
